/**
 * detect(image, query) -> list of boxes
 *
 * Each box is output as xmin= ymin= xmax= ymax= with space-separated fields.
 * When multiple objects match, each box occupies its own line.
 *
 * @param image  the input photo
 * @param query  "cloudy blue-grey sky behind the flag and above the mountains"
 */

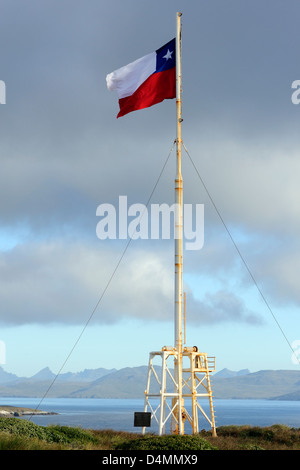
xmin=0 ymin=0 xmax=300 ymax=379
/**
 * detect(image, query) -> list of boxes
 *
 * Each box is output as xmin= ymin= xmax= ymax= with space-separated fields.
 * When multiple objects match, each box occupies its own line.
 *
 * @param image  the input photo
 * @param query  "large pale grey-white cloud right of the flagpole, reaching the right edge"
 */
xmin=185 ymin=139 xmax=300 ymax=236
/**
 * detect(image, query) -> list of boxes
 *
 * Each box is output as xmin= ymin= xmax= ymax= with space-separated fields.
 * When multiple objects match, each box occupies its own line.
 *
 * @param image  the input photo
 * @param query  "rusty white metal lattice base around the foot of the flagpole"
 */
xmin=143 ymin=346 xmax=216 ymax=436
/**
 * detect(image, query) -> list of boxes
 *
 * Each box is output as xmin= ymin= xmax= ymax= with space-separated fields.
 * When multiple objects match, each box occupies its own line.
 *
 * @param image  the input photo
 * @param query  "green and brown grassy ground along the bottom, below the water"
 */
xmin=0 ymin=418 xmax=300 ymax=450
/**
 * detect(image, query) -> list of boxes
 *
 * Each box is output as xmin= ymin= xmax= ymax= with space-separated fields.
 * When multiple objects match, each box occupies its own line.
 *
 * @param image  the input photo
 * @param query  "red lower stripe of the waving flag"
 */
xmin=117 ymin=67 xmax=176 ymax=118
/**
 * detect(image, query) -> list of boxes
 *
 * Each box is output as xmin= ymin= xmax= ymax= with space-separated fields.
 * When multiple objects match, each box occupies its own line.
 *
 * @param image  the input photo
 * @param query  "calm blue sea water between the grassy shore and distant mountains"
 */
xmin=0 ymin=397 xmax=300 ymax=433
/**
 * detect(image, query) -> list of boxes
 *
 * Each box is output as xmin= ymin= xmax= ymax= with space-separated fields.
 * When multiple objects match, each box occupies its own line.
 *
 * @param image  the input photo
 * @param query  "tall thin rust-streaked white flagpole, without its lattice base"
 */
xmin=173 ymin=12 xmax=184 ymax=434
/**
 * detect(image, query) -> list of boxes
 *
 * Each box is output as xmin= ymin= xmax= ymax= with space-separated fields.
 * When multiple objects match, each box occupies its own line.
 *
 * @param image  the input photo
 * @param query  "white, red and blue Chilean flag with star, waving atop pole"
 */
xmin=106 ymin=39 xmax=176 ymax=118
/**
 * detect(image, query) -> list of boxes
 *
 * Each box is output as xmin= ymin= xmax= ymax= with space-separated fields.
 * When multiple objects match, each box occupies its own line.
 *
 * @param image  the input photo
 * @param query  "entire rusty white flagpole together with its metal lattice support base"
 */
xmin=143 ymin=13 xmax=216 ymax=435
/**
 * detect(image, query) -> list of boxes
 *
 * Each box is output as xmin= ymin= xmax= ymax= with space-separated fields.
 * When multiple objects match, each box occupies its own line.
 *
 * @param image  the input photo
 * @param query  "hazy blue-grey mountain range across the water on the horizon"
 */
xmin=0 ymin=366 xmax=300 ymax=400
